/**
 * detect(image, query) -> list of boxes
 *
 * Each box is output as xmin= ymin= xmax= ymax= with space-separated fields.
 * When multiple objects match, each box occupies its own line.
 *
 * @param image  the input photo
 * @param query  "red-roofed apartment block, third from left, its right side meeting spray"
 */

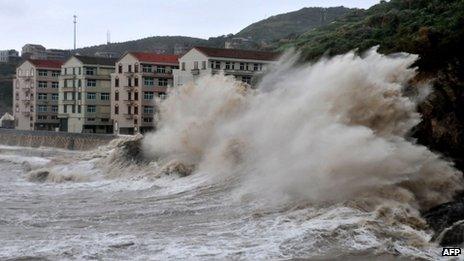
xmin=111 ymin=52 xmax=179 ymax=134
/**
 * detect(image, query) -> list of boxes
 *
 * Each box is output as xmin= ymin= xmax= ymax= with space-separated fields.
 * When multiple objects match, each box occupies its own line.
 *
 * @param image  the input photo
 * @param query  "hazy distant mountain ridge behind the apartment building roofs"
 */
xmin=77 ymin=7 xmax=353 ymax=55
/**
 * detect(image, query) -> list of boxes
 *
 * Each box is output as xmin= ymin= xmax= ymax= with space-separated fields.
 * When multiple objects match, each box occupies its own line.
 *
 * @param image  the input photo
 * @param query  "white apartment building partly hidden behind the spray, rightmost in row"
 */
xmin=173 ymin=47 xmax=279 ymax=86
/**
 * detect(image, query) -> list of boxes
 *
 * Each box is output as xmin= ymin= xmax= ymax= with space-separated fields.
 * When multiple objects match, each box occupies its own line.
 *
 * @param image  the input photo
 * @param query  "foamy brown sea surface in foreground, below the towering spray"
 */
xmin=0 ymin=143 xmax=440 ymax=260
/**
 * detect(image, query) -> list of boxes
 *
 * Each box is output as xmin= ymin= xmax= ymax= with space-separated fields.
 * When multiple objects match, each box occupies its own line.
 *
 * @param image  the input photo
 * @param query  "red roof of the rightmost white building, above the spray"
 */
xmin=193 ymin=47 xmax=280 ymax=61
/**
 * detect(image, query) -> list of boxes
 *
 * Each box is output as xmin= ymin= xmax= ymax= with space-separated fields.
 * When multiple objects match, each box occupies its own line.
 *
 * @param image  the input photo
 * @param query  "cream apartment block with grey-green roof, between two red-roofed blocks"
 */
xmin=58 ymin=55 xmax=116 ymax=133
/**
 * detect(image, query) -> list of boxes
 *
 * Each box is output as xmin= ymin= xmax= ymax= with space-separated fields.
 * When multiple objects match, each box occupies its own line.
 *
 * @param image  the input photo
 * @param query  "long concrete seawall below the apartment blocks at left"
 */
xmin=0 ymin=129 xmax=117 ymax=150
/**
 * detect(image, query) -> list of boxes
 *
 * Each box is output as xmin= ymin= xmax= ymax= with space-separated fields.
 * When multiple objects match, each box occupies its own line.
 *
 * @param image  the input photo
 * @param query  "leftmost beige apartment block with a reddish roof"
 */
xmin=13 ymin=60 xmax=62 ymax=131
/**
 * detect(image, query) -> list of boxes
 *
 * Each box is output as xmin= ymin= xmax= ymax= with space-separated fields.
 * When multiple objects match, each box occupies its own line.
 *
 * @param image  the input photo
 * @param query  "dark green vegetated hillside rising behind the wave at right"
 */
xmin=276 ymin=0 xmax=464 ymax=169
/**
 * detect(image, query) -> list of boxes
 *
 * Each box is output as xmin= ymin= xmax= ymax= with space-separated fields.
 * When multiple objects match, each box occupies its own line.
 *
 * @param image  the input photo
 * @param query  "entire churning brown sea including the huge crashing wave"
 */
xmin=0 ymin=48 xmax=463 ymax=260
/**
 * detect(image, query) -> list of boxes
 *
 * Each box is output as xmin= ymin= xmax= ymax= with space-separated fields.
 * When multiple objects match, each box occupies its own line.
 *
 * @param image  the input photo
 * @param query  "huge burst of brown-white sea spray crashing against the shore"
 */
xmin=143 ymin=48 xmax=462 ymax=209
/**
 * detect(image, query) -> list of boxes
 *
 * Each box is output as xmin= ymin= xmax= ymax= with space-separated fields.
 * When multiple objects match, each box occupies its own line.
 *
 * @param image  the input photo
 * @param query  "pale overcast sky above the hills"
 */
xmin=0 ymin=0 xmax=379 ymax=50
